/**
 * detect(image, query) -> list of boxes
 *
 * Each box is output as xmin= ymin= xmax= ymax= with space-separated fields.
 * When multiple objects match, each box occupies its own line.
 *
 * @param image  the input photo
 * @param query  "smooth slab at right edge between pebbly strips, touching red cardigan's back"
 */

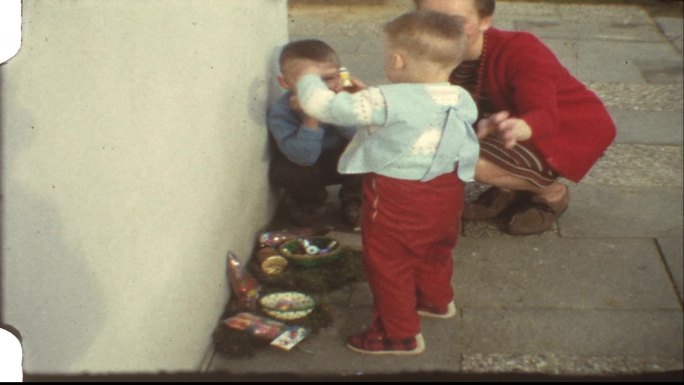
xmin=609 ymin=107 xmax=684 ymax=145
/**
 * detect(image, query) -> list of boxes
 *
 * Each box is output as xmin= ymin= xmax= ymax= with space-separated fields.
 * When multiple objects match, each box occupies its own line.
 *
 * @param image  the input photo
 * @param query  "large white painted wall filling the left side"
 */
xmin=0 ymin=0 xmax=287 ymax=374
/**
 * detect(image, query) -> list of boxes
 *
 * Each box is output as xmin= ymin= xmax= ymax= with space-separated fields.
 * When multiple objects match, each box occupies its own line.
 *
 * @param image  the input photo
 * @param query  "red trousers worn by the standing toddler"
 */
xmin=361 ymin=173 xmax=464 ymax=338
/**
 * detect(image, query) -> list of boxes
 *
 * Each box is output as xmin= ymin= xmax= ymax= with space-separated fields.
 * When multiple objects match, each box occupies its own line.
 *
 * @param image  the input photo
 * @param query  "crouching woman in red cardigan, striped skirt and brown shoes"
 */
xmin=414 ymin=0 xmax=616 ymax=235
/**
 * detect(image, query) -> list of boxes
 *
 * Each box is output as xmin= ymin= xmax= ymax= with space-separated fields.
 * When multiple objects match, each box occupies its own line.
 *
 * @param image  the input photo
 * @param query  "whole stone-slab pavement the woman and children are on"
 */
xmin=206 ymin=0 xmax=684 ymax=380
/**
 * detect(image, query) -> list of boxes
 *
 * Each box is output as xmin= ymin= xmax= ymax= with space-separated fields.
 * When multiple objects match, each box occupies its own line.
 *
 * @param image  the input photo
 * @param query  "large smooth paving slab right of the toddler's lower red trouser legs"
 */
xmin=453 ymin=237 xmax=681 ymax=310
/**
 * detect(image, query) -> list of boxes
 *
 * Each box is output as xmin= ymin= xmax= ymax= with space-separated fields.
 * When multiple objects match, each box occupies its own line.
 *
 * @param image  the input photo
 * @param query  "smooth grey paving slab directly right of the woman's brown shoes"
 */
xmin=558 ymin=184 xmax=684 ymax=239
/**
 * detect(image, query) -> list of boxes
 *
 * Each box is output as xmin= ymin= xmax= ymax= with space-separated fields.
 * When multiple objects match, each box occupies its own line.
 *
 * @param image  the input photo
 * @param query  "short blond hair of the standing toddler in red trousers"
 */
xmin=384 ymin=11 xmax=467 ymax=67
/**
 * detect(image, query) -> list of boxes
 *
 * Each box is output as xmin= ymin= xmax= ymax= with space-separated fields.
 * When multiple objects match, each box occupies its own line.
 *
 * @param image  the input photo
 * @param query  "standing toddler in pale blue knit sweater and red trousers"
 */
xmin=296 ymin=11 xmax=479 ymax=354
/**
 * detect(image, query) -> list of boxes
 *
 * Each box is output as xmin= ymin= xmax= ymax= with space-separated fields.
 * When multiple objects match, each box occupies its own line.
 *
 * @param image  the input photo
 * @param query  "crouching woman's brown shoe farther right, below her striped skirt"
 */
xmin=507 ymin=186 xmax=570 ymax=235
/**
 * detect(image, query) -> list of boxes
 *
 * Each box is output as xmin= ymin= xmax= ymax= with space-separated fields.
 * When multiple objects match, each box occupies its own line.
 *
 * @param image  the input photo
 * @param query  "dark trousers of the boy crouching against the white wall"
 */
xmin=270 ymin=147 xmax=363 ymax=205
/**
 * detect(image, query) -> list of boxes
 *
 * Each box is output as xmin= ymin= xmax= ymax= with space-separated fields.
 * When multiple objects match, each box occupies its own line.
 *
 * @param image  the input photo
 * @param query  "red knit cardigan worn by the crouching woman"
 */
xmin=483 ymin=28 xmax=616 ymax=182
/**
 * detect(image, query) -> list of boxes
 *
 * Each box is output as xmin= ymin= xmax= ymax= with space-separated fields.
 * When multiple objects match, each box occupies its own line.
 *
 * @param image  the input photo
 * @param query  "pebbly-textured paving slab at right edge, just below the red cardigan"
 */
xmin=584 ymin=143 xmax=684 ymax=188
